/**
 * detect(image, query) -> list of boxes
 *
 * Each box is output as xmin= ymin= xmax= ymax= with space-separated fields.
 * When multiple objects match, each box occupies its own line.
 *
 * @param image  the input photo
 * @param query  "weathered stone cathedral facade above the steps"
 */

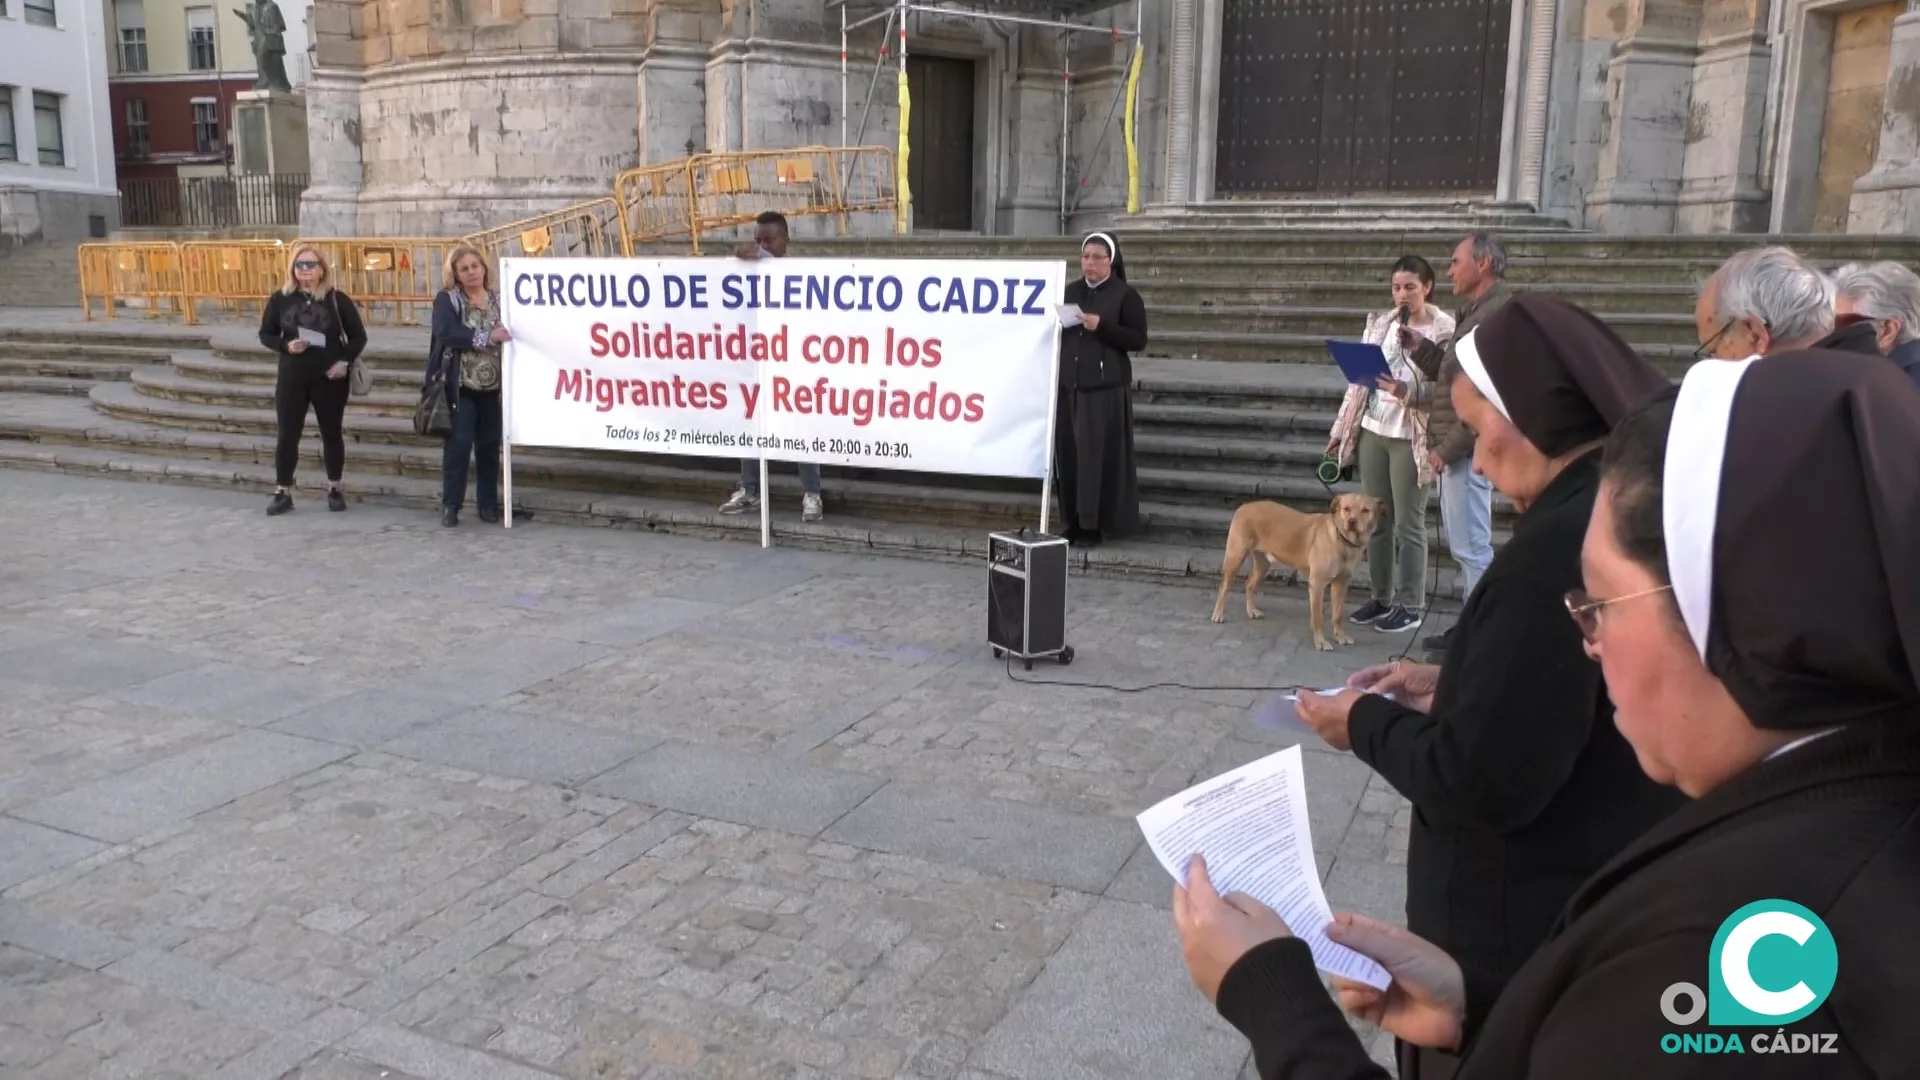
xmin=301 ymin=0 xmax=1920 ymax=234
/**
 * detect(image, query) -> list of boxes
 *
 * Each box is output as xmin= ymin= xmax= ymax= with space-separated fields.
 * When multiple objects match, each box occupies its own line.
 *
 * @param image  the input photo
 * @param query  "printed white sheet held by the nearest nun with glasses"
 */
xmin=1139 ymin=746 xmax=1392 ymax=990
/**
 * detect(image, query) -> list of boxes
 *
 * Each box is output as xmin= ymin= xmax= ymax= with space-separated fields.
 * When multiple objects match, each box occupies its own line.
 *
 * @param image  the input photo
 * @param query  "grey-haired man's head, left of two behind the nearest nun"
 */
xmin=1693 ymin=248 xmax=1834 ymax=359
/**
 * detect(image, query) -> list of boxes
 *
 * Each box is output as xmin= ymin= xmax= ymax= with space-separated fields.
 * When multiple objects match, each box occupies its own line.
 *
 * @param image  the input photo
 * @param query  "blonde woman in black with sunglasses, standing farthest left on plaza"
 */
xmin=259 ymin=244 xmax=367 ymax=515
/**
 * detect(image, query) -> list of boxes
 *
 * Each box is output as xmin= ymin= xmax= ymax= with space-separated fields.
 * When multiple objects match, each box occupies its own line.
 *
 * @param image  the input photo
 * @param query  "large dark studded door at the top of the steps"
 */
xmin=1213 ymin=0 xmax=1513 ymax=198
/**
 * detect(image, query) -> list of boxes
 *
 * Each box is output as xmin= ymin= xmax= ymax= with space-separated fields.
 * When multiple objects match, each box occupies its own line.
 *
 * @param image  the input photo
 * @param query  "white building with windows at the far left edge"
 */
xmin=0 ymin=0 xmax=117 ymax=244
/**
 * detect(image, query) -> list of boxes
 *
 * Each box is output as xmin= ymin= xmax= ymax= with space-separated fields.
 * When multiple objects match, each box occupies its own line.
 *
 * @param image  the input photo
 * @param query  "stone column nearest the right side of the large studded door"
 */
xmin=1586 ymin=0 xmax=1699 ymax=233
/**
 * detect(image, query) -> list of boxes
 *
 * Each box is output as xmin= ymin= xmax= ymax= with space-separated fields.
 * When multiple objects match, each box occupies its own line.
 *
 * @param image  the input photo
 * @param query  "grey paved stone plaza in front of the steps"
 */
xmin=0 ymin=471 xmax=1409 ymax=1080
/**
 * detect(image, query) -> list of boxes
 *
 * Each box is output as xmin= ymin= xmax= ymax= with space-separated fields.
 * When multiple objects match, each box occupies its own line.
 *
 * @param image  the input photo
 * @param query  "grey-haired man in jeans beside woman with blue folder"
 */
xmin=1400 ymin=233 xmax=1513 ymax=653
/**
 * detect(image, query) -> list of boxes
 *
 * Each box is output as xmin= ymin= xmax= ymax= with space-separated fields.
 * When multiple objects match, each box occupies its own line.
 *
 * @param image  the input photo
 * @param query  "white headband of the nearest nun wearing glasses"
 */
xmin=1661 ymin=359 xmax=1755 ymax=661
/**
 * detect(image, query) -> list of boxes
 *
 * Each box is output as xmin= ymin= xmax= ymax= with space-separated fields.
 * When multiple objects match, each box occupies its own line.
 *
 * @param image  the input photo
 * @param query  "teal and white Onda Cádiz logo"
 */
xmin=1661 ymin=899 xmax=1839 ymax=1053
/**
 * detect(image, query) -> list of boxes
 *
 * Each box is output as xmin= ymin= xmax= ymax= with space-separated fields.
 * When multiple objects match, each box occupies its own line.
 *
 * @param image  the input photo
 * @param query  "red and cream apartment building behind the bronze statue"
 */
xmin=105 ymin=0 xmax=309 ymax=181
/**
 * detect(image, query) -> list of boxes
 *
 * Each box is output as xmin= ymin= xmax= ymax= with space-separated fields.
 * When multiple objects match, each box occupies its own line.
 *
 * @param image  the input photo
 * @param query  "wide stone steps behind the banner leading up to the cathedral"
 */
xmin=0 ymin=229 xmax=1920 ymax=596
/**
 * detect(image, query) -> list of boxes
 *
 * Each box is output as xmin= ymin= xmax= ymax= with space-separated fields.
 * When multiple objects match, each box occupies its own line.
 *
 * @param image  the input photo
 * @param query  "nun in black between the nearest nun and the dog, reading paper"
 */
xmin=1300 ymin=294 xmax=1682 ymax=1080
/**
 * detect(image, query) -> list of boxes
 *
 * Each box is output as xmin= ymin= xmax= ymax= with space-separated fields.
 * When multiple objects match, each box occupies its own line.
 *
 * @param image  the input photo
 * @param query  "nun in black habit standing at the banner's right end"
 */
xmin=1054 ymin=233 xmax=1146 ymax=546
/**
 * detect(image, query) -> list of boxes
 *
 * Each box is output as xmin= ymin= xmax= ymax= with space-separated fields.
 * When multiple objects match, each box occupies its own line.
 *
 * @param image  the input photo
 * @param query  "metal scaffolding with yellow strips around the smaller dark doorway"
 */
xmin=828 ymin=0 xmax=1146 ymax=233
